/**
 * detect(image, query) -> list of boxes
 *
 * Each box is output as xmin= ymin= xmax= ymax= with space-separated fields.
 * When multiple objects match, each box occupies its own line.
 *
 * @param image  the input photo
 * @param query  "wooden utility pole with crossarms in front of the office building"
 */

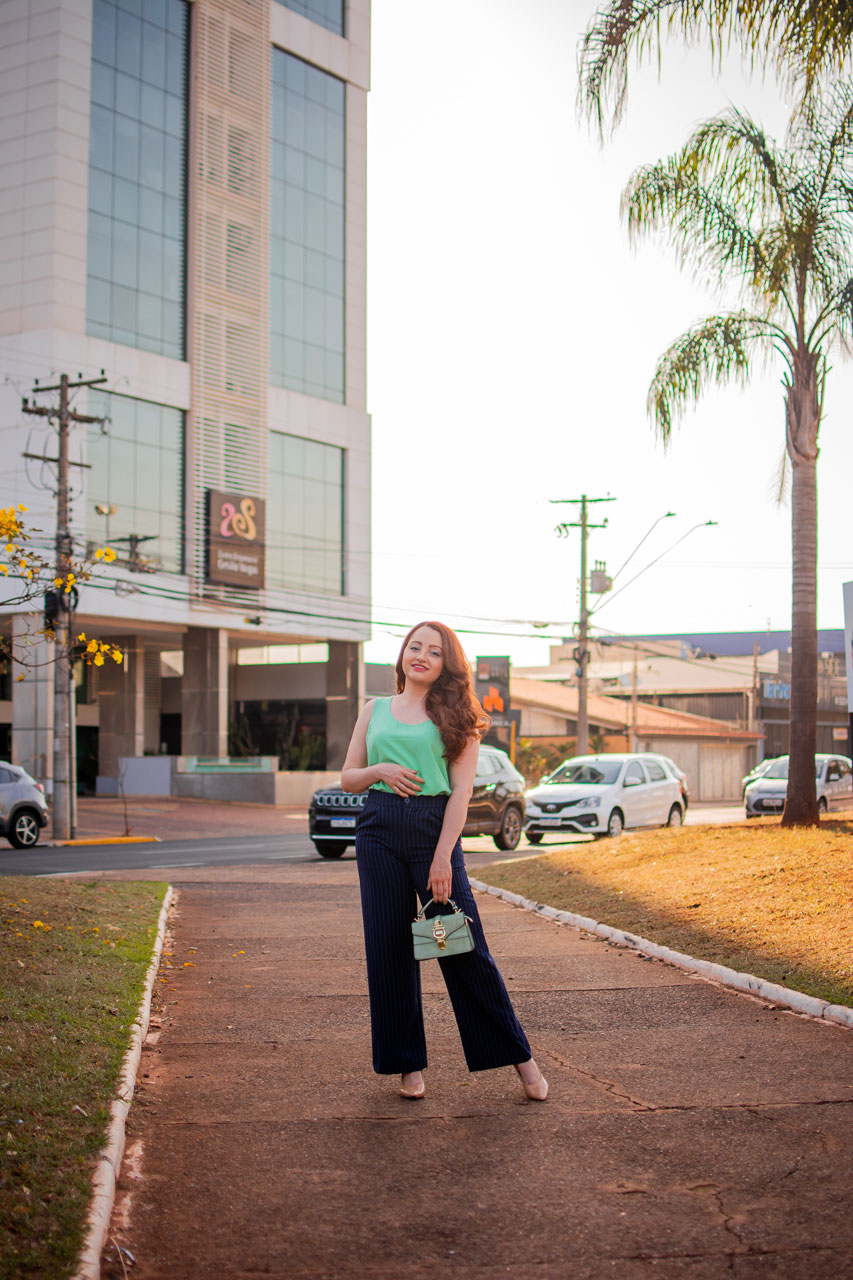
xmin=22 ymin=374 xmax=106 ymax=840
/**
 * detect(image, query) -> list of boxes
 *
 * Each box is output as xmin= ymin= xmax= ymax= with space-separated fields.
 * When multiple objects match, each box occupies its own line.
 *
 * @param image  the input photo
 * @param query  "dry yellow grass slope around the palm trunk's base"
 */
xmin=476 ymin=815 xmax=853 ymax=1005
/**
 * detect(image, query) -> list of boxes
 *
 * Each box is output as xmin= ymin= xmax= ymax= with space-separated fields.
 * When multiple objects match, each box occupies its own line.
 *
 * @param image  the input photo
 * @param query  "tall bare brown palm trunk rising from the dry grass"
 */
xmin=783 ymin=379 xmax=820 ymax=827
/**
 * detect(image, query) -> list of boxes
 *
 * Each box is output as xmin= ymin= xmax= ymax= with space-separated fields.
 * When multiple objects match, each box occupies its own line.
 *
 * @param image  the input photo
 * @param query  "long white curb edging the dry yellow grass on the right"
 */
xmin=470 ymin=879 xmax=853 ymax=1027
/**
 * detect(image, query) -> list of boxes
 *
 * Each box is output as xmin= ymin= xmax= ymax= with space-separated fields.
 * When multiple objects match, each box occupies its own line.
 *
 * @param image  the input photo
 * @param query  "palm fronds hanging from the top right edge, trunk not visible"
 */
xmin=579 ymin=0 xmax=853 ymax=128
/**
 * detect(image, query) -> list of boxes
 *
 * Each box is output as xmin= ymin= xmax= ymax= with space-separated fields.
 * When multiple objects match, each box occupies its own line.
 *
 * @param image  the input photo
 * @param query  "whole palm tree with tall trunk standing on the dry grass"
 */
xmin=622 ymin=84 xmax=853 ymax=826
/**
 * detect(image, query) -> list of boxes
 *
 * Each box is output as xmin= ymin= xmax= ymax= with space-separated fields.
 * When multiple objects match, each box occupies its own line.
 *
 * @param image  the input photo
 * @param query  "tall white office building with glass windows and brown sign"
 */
xmin=0 ymin=0 xmax=370 ymax=794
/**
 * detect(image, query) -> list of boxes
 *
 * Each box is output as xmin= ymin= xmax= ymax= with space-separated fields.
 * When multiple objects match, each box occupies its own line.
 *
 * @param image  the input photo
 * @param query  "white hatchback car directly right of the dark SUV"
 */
xmin=524 ymin=754 xmax=684 ymax=845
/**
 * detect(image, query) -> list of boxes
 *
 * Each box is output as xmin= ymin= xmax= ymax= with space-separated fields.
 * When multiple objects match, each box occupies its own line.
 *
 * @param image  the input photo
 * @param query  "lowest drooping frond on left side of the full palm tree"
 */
xmin=647 ymin=311 xmax=784 ymax=444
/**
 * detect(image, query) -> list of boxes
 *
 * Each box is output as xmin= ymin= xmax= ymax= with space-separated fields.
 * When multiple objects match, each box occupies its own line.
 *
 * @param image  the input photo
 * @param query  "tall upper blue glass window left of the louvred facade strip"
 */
xmin=86 ymin=0 xmax=188 ymax=360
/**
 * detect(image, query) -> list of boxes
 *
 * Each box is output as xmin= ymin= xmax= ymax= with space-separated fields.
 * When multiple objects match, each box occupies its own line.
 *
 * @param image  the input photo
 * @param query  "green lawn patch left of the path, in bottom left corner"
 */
xmin=0 ymin=877 xmax=167 ymax=1280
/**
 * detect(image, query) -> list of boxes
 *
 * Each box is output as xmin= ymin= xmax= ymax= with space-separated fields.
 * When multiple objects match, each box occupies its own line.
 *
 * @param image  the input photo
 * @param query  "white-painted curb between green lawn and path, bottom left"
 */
xmin=72 ymin=884 xmax=174 ymax=1280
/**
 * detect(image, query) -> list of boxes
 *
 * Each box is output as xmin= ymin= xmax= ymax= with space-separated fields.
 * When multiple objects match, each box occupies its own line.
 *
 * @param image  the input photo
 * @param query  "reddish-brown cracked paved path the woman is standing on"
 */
xmin=102 ymin=860 xmax=853 ymax=1280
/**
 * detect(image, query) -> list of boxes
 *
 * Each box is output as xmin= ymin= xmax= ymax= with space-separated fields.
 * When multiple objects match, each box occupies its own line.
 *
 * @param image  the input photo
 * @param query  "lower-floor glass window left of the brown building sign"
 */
xmin=86 ymin=393 xmax=183 ymax=573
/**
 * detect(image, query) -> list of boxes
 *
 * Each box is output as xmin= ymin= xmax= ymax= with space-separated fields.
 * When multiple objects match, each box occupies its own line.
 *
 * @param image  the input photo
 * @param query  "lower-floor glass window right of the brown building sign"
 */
xmin=266 ymin=431 xmax=343 ymax=595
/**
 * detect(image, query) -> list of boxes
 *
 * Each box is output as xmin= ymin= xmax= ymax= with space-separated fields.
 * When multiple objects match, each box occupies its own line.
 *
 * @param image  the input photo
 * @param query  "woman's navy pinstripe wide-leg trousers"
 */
xmin=356 ymin=790 xmax=532 ymax=1075
